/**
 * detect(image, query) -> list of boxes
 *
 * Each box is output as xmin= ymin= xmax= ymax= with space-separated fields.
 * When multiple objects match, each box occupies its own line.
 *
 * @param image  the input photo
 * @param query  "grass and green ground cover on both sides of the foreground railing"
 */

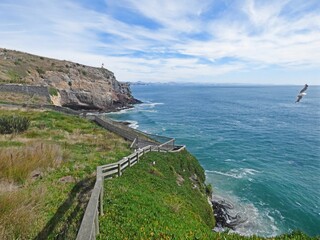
xmin=0 ymin=108 xmax=317 ymax=240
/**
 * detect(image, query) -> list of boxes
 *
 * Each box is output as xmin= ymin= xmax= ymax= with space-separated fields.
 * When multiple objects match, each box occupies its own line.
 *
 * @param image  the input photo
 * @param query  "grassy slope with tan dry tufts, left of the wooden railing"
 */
xmin=0 ymin=109 xmax=130 ymax=240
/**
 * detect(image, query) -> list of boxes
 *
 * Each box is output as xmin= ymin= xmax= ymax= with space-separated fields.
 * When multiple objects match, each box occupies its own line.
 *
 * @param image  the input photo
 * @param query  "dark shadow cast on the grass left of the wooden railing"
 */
xmin=34 ymin=178 xmax=95 ymax=240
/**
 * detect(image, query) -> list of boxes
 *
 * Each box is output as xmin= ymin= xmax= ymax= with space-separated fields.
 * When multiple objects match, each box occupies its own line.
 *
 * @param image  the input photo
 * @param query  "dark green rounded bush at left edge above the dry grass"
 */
xmin=0 ymin=116 xmax=30 ymax=134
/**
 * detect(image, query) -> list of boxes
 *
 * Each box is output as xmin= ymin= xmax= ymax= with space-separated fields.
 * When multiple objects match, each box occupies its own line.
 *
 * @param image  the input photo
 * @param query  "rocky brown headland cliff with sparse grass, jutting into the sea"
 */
xmin=0 ymin=48 xmax=139 ymax=111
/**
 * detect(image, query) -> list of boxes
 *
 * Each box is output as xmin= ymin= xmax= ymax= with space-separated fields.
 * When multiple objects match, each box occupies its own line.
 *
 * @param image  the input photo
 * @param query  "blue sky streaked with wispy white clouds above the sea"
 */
xmin=0 ymin=0 xmax=320 ymax=85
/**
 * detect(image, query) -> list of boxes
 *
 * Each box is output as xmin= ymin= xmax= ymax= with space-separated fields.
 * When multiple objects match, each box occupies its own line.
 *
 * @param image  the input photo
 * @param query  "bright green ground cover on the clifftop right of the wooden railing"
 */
xmin=98 ymin=151 xmax=316 ymax=240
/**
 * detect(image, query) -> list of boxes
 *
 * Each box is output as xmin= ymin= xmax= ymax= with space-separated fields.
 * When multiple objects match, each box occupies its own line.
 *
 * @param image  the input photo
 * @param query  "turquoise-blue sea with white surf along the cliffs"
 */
xmin=110 ymin=84 xmax=320 ymax=236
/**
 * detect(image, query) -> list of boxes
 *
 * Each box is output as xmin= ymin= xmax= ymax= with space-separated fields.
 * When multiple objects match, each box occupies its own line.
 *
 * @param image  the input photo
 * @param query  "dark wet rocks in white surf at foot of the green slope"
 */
xmin=211 ymin=200 xmax=246 ymax=232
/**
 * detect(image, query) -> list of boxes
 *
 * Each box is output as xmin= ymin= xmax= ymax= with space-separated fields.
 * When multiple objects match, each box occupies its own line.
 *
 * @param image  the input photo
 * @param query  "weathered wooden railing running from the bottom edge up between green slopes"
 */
xmin=77 ymin=146 xmax=153 ymax=240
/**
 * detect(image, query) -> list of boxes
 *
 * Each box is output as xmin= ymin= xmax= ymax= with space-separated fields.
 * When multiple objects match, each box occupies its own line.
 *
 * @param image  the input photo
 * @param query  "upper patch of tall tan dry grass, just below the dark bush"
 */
xmin=0 ymin=142 xmax=63 ymax=184
